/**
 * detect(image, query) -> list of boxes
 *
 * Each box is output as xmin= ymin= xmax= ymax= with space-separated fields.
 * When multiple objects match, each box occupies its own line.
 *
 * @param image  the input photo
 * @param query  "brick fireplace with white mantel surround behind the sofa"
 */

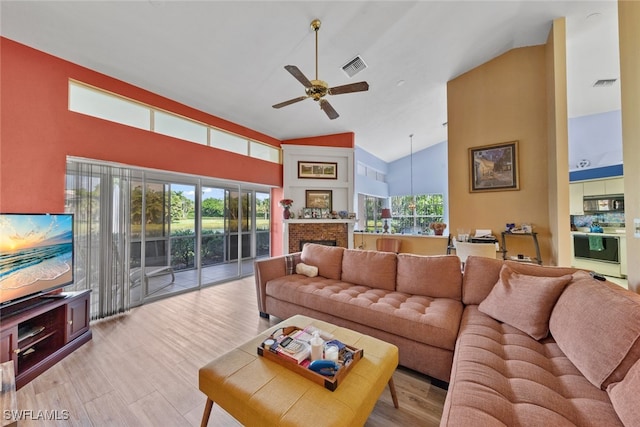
xmin=283 ymin=220 xmax=354 ymax=253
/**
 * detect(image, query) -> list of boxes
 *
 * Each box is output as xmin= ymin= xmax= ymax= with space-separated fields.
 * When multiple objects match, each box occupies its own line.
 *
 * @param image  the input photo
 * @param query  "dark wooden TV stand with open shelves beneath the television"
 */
xmin=0 ymin=290 xmax=91 ymax=389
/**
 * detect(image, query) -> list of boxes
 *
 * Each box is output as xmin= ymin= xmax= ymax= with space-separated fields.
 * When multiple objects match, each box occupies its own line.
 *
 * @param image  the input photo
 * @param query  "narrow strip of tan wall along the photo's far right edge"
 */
xmin=618 ymin=0 xmax=640 ymax=293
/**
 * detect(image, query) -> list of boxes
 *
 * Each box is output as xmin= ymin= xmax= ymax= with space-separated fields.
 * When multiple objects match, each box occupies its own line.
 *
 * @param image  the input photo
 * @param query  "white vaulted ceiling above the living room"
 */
xmin=0 ymin=0 xmax=619 ymax=161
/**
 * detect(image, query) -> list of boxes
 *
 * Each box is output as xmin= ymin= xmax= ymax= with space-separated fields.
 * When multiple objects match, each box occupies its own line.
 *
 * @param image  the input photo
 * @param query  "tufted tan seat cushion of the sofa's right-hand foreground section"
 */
xmin=440 ymin=306 xmax=622 ymax=427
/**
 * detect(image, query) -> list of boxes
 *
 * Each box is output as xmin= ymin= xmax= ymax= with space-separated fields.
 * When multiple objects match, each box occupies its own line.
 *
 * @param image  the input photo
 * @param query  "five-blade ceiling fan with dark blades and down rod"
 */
xmin=273 ymin=19 xmax=369 ymax=120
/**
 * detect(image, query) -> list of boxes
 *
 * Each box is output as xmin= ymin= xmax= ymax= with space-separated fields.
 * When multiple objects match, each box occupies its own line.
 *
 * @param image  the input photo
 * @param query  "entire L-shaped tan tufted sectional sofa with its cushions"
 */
xmin=256 ymin=245 xmax=640 ymax=426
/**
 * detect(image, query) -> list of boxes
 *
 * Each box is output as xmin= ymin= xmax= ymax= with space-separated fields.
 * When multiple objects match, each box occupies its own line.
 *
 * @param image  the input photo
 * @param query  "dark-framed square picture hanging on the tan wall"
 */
xmin=469 ymin=141 xmax=520 ymax=193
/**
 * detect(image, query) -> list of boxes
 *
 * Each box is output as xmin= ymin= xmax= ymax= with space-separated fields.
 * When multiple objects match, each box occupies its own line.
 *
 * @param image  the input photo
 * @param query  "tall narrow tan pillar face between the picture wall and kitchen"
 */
xmin=546 ymin=18 xmax=572 ymax=266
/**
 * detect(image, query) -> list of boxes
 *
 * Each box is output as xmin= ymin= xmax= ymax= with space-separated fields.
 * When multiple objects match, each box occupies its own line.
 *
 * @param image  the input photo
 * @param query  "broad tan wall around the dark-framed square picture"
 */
xmin=447 ymin=46 xmax=552 ymax=264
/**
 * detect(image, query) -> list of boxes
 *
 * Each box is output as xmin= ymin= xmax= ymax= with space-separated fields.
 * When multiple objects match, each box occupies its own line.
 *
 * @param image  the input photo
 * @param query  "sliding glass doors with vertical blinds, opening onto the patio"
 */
xmin=67 ymin=157 xmax=271 ymax=313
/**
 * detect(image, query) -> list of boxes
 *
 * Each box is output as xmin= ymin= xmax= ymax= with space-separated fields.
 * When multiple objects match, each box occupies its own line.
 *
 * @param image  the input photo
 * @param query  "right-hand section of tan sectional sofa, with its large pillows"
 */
xmin=440 ymin=257 xmax=640 ymax=426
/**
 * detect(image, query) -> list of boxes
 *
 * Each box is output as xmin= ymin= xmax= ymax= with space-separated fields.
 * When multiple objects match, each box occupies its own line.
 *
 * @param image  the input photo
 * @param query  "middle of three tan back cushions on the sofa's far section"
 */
xmin=342 ymin=249 xmax=397 ymax=291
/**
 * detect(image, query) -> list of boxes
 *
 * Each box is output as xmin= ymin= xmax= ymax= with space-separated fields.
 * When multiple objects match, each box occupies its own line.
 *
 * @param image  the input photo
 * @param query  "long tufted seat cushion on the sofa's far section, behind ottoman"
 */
xmin=266 ymin=275 xmax=462 ymax=350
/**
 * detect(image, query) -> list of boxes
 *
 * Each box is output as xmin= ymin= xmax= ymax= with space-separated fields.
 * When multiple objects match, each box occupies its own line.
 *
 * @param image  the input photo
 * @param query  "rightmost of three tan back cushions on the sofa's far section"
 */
xmin=396 ymin=254 xmax=462 ymax=300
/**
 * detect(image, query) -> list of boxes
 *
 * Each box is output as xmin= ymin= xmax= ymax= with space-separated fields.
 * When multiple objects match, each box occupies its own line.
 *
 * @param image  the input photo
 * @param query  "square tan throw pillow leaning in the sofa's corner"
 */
xmin=478 ymin=265 xmax=572 ymax=340
